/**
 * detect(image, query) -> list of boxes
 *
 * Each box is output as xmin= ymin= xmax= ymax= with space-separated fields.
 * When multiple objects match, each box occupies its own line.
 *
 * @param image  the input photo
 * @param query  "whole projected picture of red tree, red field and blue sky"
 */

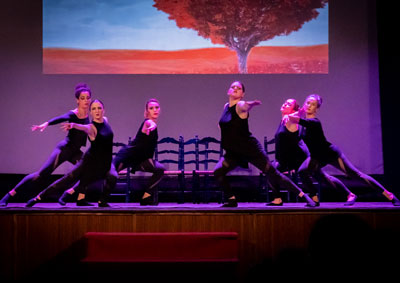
xmin=43 ymin=0 xmax=329 ymax=74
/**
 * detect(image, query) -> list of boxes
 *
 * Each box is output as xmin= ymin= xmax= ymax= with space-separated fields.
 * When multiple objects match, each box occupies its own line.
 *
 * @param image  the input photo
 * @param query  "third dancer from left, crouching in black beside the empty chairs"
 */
xmin=90 ymin=98 xmax=165 ymax=205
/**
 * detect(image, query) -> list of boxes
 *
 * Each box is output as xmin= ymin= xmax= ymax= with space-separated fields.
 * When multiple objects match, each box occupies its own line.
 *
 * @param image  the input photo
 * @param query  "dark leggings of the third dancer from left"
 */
xmin=102 ymin=158 xmax=165 ymax=200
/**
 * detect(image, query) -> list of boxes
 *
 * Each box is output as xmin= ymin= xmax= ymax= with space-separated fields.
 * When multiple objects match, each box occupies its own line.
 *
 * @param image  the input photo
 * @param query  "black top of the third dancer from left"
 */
xmin=128 ymin=119 xmax=158 ymax=162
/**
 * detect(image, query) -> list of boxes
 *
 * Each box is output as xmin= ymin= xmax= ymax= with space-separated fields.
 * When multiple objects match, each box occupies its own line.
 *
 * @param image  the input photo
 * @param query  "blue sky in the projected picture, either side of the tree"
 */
xmin=43 ymin=0 xmax=329 ymax=50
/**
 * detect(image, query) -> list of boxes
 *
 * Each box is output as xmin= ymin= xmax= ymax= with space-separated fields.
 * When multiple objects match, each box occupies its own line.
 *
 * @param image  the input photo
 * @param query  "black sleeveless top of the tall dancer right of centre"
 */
xmin=219 ymin=104 xmax=265 ymax=164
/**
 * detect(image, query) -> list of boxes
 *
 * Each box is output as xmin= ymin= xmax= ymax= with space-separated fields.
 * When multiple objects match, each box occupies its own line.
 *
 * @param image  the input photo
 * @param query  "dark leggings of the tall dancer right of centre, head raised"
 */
xmin=214 ymin=152 xmax=302 ymax=198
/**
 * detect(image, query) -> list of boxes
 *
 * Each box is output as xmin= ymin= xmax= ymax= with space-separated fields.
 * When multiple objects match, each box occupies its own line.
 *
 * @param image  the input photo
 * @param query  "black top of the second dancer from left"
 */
xmin=84 ymin=121 xmax=114 ymax=171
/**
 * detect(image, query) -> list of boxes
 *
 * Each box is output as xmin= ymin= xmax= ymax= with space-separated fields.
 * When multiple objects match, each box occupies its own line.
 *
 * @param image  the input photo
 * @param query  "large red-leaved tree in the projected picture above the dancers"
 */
xmin=153 ymin=0 xmax=328 ymax=73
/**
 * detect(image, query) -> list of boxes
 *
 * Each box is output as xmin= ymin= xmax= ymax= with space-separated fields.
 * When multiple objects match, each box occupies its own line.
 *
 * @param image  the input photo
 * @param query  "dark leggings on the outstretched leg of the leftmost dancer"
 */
xmin=13 ymin=145 xmax=83 ymax=195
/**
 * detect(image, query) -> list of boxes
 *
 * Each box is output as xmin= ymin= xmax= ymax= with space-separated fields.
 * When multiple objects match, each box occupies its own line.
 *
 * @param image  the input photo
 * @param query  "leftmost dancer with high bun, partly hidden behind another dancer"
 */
xmin=0 ymin=84 xmax=92 ymax=206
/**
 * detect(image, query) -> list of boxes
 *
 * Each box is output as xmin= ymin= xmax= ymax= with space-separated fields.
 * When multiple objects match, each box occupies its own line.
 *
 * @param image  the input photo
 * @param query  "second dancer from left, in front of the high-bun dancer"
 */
xmin=26 ymin=99 xmax=114 ymax=207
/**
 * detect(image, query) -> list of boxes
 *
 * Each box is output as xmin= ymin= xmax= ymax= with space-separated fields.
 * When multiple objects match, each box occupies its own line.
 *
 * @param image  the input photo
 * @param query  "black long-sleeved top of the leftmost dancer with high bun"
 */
xmin=48 ymin=111 xmax=90 ymax=149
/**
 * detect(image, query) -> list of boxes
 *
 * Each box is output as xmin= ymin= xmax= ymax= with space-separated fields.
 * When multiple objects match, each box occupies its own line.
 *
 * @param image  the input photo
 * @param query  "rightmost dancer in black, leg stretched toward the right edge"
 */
xmin=288 ymin=94 xmax=400 ymax=206
